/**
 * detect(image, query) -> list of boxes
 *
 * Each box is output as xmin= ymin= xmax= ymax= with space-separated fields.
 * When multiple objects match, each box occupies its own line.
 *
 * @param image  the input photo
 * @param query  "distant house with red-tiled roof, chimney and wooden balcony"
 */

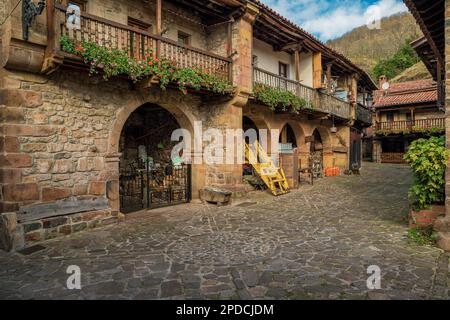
xmin=373 ymin=77 xmax=445 ymax=163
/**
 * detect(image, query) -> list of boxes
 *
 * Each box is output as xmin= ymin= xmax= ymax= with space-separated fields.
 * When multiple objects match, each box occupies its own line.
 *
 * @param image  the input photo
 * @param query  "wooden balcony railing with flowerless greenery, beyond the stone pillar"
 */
xmin=253 ymin=67 xmax=351 ymax=119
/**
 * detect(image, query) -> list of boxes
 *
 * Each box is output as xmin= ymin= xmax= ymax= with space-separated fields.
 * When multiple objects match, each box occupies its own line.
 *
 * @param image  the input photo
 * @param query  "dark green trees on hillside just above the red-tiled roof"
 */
xmin=373 ymin=40 xmax=420 ymax=79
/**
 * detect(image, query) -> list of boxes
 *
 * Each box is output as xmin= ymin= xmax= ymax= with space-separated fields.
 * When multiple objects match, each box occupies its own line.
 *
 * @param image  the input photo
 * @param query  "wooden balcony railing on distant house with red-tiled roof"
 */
xmin=376 ymin=118 xmax=445 ymax=134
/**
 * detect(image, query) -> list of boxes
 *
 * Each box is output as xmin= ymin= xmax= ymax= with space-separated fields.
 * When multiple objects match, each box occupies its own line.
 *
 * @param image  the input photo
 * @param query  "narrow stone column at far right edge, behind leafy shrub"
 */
xmin=434 ymin=0 xmax=450 ymax=251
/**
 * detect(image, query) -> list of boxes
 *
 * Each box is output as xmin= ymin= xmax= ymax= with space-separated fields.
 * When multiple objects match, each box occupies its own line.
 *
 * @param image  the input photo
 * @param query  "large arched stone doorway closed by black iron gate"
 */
xmin=118 ymin=103 xmax=192 ymax=213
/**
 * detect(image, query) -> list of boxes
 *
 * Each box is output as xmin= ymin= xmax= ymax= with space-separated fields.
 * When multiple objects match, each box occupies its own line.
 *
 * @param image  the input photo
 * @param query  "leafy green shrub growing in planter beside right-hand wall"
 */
xmin=404 ymin=136 xmax=450 ymax=210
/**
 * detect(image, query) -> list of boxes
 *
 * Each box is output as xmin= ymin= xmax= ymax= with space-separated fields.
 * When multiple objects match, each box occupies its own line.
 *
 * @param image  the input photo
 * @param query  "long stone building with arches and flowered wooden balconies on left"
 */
xmin=0 ymin=0 xmax=376 ymax=250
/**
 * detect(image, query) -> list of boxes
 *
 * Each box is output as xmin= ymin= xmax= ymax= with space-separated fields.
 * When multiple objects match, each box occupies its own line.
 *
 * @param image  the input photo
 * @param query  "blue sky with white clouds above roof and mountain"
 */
xmin=261 ymin=0 xmax=407 ymax=41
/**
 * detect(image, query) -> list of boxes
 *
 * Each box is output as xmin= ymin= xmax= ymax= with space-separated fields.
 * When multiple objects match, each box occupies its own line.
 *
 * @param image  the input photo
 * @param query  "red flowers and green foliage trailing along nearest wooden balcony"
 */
xmin=60 ymin=36 xmax=232 ymax=94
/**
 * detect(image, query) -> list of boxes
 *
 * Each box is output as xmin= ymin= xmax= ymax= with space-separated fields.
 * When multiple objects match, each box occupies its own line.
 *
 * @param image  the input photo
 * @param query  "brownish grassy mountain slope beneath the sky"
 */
xmin=327 ymin=13 xmax=422 ymax=75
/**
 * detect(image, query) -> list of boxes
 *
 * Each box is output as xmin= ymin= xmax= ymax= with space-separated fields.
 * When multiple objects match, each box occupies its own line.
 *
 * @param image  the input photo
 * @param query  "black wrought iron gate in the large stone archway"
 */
xmin=120 ymin=162 xmax=192 ymax=213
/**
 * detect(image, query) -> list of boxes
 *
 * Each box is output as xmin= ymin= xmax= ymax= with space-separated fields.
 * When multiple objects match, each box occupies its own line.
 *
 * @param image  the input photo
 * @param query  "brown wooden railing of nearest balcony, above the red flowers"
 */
xmin=55 ymin=4 xmax=232 ymax=81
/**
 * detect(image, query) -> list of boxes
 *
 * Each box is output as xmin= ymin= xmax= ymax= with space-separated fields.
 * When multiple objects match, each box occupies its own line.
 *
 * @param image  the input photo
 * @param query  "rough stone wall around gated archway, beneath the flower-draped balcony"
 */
xmin=0 ymin=70 xmax=246 ymax=212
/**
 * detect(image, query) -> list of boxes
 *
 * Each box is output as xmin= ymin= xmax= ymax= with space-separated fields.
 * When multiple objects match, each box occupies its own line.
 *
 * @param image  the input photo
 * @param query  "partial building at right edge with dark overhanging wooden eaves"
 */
xmin=404 ymin=0 xmax=450 ymax=251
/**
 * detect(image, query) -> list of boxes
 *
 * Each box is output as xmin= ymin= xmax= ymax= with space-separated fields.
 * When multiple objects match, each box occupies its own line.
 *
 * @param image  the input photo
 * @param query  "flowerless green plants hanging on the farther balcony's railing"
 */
xmin=253 ymin=83 xmax=308 ymax=113
